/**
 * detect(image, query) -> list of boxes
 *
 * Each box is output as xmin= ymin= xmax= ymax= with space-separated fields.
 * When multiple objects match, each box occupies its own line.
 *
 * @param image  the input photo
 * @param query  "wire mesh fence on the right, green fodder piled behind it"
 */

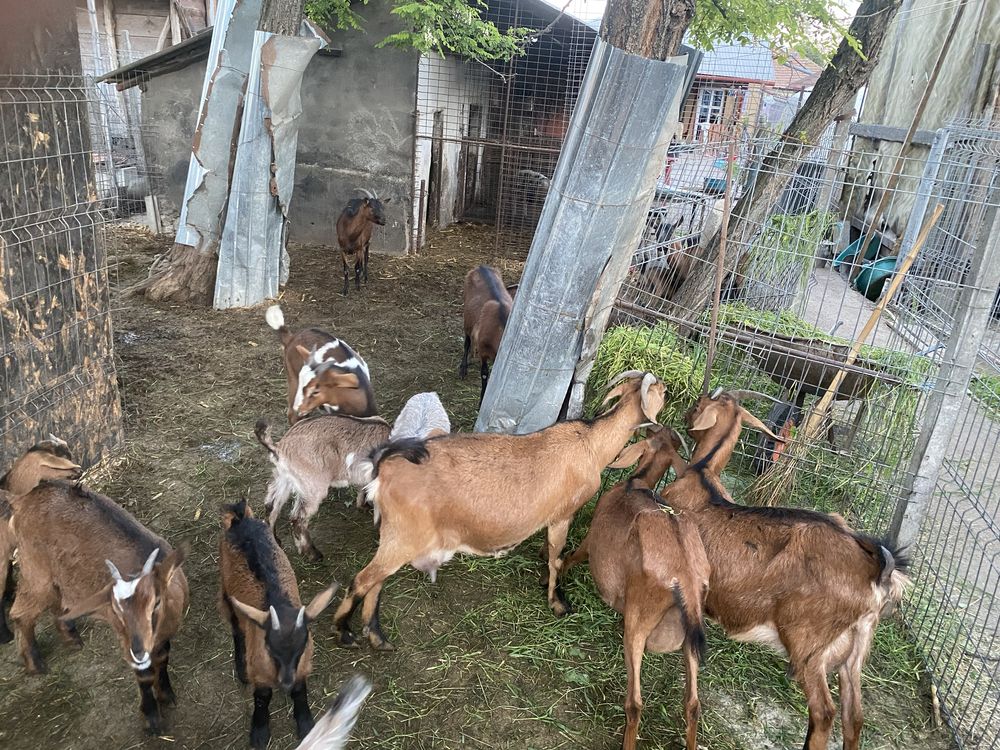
xmin=591 ymin=114 xmax=1000 ymax=748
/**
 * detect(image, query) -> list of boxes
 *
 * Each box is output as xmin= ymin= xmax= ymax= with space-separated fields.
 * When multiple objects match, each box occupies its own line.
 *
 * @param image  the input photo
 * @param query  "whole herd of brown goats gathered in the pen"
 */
xmin=0 ymin=258 xmax=907 ymax=750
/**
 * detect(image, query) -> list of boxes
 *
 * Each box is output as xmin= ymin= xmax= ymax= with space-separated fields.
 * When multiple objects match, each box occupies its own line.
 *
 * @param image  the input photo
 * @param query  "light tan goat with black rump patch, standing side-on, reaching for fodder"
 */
xmin=334 ymin=372 xmax=664 ymax=649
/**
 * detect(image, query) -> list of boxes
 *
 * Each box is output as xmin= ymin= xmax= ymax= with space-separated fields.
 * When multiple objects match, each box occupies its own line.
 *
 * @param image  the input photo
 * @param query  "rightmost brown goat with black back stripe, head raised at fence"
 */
xmin=664 ymin=392 xmax=908 ymax=750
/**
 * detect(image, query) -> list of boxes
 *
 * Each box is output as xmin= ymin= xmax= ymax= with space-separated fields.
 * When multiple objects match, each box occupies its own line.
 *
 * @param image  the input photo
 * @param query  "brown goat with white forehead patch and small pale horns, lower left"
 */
xmin=10 ymin=481 xmax=188 ymax=734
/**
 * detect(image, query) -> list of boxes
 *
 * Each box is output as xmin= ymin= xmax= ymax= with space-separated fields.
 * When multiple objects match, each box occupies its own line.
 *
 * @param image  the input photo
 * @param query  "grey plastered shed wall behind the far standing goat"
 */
xmin=143 ymin=0 xmax=418 ymax=253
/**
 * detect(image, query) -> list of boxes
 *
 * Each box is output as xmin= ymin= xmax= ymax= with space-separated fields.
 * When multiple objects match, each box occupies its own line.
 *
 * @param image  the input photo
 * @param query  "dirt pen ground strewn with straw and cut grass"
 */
xmin=0 ymin=227 xmax=953 ymax=750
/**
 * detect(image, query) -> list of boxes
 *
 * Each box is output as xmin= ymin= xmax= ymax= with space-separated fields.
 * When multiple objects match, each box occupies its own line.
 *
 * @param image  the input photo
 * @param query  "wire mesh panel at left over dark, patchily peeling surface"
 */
xmin=0 ymin=76 xmax=121 ymax=465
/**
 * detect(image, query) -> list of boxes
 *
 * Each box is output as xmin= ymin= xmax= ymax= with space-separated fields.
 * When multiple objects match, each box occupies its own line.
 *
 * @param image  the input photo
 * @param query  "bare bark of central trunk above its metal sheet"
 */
xmin=601 ymin=0 xmax=694 ymax=60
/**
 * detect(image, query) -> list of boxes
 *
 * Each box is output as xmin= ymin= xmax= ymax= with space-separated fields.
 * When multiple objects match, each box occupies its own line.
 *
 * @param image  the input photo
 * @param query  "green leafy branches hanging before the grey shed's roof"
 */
xmin=305 ymin=0 xmax=535 ymax=60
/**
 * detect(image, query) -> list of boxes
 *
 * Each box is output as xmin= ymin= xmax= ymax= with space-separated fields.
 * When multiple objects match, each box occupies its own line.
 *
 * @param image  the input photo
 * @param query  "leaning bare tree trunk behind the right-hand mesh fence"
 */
xmin=670 ymin=0 xmax=900 ymax=321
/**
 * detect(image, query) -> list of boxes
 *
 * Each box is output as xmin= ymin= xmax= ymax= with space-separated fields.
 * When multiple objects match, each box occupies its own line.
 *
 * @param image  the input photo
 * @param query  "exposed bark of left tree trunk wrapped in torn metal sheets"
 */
xmin=131 ymin=0 xmax=304 ymax=305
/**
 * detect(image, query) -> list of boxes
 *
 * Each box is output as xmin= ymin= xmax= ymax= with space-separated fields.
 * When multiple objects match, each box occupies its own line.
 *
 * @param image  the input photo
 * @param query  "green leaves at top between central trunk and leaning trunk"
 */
xmin=689 ymin=0 xmax=862 ymax=61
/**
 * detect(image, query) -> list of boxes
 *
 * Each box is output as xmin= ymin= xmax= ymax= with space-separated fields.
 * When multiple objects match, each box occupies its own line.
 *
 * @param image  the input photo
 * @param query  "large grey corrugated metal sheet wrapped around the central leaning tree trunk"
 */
xmin=476 ymin=41 xmax=687 ymax=434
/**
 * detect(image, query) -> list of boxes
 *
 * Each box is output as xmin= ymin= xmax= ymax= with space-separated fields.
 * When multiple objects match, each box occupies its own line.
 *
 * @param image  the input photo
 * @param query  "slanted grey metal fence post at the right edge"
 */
xmin=889 ymin=198 xmax=1000 ymax=547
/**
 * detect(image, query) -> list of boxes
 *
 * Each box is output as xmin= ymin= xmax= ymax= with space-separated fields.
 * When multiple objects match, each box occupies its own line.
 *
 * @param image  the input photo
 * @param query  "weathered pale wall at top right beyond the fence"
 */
xmin=848 ymin=0 xmax=1000 ymax=234
